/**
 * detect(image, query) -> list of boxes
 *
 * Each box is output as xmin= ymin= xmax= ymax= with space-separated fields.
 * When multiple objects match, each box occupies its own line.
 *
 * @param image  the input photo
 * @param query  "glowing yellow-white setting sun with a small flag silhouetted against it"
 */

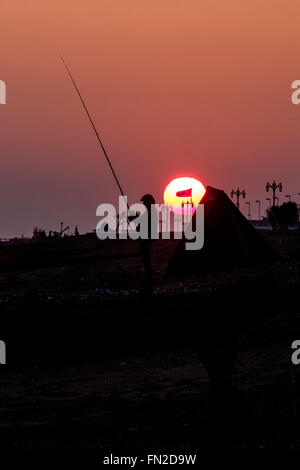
xmin=164 ymin=176 xmax=205 ymax=208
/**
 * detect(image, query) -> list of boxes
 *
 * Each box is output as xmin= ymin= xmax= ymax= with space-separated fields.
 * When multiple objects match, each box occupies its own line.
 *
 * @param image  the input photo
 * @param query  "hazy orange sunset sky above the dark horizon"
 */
xmin=0 ymin=0 xmax=300 ymax=237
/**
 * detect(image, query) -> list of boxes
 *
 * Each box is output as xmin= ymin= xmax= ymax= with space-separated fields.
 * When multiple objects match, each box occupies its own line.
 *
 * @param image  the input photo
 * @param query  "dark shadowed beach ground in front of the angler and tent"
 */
xmin=0 ymin=229 xmax=300 ymax=458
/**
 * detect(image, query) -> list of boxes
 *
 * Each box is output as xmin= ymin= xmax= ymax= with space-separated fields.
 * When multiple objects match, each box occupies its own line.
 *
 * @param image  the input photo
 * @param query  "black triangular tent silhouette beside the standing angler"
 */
xmin=165 ymin=186 xmax=278 ymax=278
